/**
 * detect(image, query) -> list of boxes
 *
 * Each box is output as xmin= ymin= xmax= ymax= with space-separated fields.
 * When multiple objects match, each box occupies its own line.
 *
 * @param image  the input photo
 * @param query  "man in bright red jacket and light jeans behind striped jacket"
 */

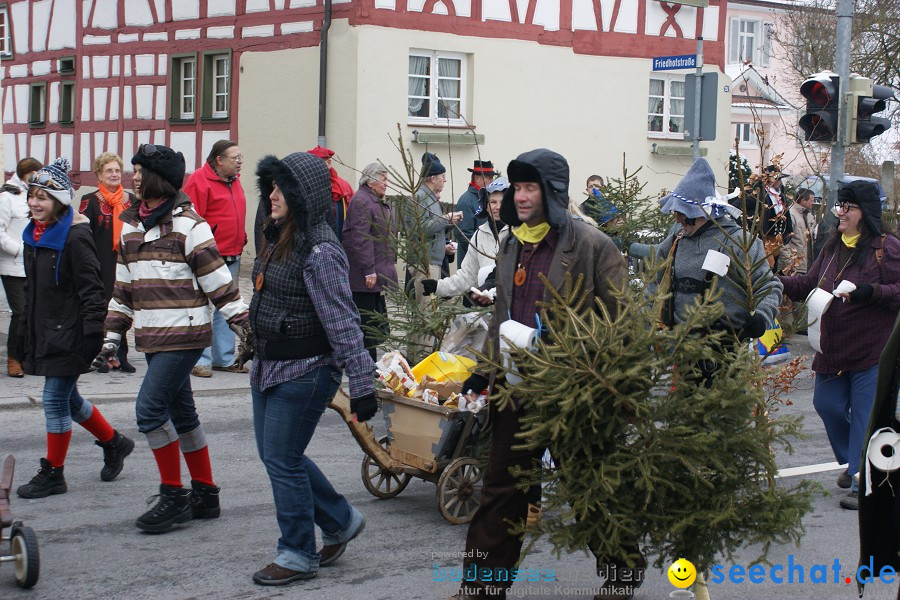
xmin=183 ymin=140 xmax=247 ymax=377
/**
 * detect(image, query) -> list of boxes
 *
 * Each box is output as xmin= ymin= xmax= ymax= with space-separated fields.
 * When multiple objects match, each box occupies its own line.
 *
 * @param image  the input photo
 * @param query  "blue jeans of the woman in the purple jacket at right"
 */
xmin=813 ymin=365 xmax=878 ymax=490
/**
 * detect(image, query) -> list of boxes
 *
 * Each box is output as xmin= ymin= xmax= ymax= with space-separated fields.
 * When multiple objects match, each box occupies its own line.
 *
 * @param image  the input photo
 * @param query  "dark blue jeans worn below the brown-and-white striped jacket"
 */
xmin=135 ymin=348 xmax=205 ymax=452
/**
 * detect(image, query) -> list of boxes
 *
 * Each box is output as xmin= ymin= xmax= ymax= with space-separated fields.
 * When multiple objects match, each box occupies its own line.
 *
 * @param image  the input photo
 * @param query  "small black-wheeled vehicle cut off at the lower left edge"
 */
xmin=0 ymin=454 xmax=41 ymax=588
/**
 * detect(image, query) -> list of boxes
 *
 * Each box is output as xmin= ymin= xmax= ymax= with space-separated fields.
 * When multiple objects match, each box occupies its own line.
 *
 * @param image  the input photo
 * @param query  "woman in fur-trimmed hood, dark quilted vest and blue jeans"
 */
xmin=250 ymin=152 xmax=377 ymax=585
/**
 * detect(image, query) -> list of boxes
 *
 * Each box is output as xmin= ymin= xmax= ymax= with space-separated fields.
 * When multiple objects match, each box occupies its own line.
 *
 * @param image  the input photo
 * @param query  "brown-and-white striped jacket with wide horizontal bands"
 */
xmin=105 ymin=192 xmax=247 ymax=352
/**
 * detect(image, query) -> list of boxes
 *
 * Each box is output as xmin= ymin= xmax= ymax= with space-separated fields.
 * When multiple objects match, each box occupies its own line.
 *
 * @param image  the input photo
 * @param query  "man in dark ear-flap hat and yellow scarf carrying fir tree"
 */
xmin=448 ymin=148 xmax=626 ymax=598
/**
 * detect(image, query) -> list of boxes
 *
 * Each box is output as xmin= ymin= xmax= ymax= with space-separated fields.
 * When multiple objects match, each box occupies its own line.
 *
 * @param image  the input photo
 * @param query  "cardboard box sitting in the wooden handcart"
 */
xmin=379 ymin=392 xmax=468 ymax=473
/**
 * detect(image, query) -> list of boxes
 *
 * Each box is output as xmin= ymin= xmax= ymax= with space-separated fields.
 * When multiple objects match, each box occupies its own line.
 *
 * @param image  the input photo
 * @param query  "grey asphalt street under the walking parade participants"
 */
xmin=0 ymin=346 xmax=897 ymax=600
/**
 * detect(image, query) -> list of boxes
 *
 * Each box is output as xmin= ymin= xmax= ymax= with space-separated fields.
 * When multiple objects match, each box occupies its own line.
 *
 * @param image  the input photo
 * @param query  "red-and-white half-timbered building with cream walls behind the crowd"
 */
xmin=0 ymin=0 xmax=733 ymax=248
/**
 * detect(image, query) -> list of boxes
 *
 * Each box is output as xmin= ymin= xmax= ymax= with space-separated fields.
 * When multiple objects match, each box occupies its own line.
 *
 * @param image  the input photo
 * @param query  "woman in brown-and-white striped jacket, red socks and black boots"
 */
xmin=98 ymin=144 xmax=249 ymax=533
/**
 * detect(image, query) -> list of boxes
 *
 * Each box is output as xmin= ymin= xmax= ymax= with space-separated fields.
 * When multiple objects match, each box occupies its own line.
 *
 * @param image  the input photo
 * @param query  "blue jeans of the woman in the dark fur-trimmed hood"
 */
xmin=251 ymin=367 xmax=363 ymax=571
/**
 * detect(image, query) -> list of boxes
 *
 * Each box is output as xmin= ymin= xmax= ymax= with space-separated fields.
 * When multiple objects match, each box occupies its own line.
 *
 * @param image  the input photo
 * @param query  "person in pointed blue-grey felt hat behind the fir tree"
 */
xmin=632 ymin=158 xmax=782 ymax=366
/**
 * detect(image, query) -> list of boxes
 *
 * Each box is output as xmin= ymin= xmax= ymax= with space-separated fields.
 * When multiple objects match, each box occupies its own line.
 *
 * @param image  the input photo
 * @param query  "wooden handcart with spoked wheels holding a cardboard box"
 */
xmin=331 ymin=391 xmax=488 ymax=525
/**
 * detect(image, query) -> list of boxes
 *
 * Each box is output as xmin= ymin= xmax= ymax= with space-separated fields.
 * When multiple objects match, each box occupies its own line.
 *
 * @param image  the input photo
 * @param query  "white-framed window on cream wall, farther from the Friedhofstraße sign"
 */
xmin=407 ymin=50 xmax=467 ymax=125
